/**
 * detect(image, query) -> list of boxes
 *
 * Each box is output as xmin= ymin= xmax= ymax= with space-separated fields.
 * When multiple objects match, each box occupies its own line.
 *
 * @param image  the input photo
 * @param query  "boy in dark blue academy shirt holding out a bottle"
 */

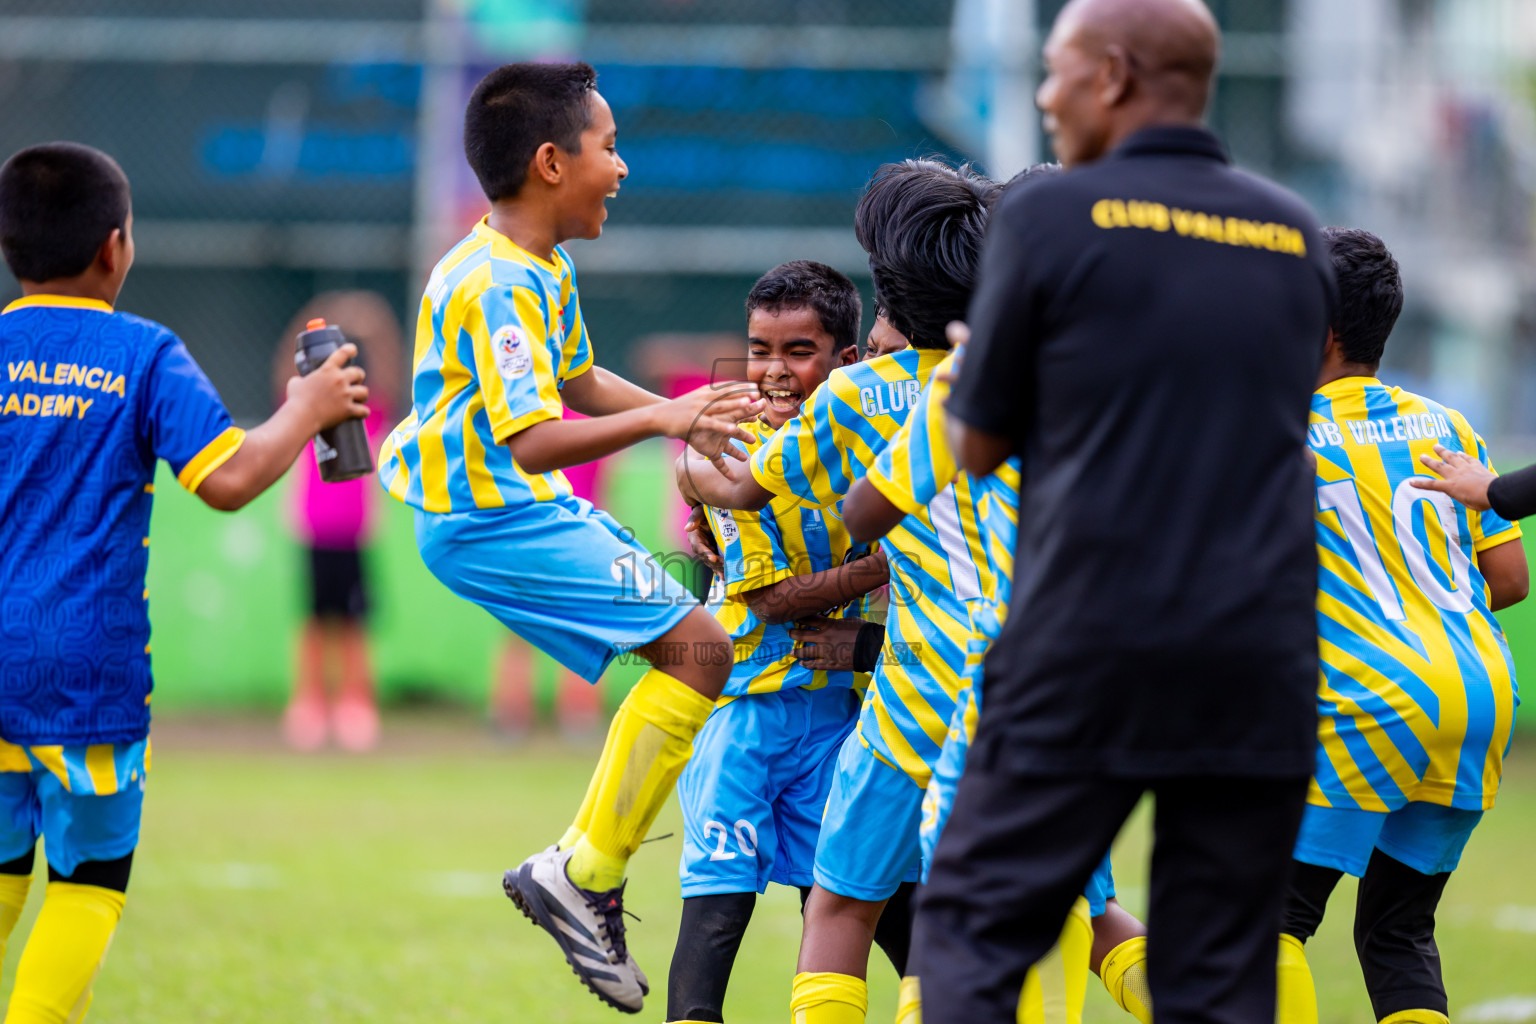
xmin=0 ymin=143 xmax=367 ymax=1024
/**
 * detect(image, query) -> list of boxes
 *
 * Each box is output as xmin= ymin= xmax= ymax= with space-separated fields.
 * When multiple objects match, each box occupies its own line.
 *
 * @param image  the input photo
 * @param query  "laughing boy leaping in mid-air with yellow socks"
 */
xmin=379 ymin=63 xmax=760 ymax=1013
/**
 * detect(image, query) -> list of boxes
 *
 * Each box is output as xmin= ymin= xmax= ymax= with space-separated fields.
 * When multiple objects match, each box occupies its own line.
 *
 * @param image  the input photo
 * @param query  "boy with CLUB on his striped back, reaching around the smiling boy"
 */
xmin=693 ymin=161 xmax=998 ymax=1024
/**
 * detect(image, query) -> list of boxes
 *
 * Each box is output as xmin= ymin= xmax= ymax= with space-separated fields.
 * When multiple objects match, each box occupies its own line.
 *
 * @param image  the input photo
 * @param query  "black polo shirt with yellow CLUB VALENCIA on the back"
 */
xmin=948 ymin=126 xmax=1335 ymax=777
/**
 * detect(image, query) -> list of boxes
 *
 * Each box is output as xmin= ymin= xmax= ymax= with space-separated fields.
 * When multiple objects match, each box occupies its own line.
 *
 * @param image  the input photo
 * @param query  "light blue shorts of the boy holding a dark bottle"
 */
xmin=0 ymin=769 xmax=144 ymax=875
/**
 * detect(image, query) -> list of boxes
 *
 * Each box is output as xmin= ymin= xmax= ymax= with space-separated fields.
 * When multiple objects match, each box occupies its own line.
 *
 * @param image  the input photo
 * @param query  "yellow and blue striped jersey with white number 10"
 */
xmin=1307 ymin=376 xmax=1521 ymax=811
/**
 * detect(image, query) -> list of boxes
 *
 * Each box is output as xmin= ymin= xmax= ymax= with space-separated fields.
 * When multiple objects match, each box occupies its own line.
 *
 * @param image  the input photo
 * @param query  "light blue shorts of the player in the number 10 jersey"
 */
xmin=1295 ymin=803 xmax=1482 ymax=878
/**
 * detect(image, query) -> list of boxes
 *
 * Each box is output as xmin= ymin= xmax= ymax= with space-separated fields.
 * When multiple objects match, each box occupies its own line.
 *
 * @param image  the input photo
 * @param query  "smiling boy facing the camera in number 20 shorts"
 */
xmin=667 ymin=261 xmax=908 ymax=1022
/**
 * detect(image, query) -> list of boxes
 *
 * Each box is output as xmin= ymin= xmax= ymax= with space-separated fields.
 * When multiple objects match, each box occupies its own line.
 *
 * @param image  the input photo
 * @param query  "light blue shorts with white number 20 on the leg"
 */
xmin=677 ymin=686 xmax=859 ymax=898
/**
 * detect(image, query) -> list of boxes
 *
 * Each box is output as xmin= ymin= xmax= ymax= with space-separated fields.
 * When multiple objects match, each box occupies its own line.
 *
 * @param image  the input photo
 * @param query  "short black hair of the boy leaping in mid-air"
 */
xmin=464 ymin=63 xmax=598 ymax=203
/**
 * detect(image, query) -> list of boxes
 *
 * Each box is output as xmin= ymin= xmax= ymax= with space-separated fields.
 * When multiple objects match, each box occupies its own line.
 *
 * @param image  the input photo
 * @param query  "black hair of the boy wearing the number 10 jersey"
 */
xmin=1322 ymin=227 xmax=1402 ymax=367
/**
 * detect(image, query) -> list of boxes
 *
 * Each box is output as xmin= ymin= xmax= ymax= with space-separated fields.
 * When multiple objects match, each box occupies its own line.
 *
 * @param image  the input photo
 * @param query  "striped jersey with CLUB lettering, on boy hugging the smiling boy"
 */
xmin=751 ymin=348 xmax=982 ymax=786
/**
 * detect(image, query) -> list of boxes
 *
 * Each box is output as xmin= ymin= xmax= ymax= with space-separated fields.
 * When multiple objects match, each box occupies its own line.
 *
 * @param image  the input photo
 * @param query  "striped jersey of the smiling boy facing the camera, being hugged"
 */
xmin=705 ymin=422 xmax=863 ymax=697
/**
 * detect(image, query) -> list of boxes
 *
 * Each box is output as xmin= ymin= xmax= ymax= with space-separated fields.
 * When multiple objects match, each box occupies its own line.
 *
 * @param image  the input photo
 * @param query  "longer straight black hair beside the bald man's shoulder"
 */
xmin=854 ymin=158 xmax=1000 ymax=348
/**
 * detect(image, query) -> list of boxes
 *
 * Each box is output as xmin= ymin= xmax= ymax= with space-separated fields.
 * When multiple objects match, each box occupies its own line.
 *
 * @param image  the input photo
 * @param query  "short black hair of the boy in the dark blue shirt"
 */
xmin=0 ymin=143 xmax=132 ymax=281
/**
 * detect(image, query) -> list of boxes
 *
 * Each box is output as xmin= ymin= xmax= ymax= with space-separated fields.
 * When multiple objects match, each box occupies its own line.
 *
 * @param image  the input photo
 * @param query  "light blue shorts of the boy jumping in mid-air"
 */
xmin=416 ymin=497 xmax=699 ymax=682
